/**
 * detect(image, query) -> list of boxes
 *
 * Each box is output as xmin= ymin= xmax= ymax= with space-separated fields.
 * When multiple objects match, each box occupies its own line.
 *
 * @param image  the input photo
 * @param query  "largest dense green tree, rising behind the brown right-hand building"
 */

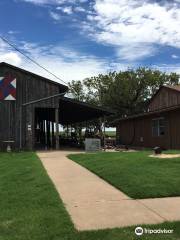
xmin=105 ymin=68 xmax=179 ymax=116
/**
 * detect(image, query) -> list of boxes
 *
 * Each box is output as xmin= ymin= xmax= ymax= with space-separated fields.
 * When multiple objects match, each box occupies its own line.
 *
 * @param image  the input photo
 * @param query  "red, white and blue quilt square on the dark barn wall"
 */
xmin=0 ymin=74 xmax=16 ymax=101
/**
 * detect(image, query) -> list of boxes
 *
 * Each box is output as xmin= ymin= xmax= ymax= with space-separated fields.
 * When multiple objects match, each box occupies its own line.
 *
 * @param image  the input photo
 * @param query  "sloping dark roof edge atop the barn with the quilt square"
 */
xmin=0 ymin=62 xmax=68 ymax=92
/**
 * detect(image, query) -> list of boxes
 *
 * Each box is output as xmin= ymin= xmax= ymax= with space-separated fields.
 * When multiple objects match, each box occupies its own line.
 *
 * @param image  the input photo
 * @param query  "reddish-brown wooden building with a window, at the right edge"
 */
xmin=115 ymin=85 xmax=180 ymax=149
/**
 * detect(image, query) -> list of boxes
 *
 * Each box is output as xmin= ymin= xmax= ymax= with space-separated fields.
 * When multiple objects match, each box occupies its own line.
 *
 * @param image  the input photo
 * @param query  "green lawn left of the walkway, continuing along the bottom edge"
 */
xmin=0 ymin=153 xmax=180 ymax=240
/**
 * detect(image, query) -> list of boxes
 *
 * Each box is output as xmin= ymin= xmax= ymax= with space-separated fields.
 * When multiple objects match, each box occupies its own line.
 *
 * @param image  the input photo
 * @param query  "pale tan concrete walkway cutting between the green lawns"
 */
xmin=38 ymin=151 xmax=180 ymax=230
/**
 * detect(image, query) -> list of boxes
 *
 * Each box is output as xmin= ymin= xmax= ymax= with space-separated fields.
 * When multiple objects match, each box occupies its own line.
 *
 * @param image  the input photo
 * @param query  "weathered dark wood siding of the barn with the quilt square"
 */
xmin=0 ymin=63 xmax=62 ymax=149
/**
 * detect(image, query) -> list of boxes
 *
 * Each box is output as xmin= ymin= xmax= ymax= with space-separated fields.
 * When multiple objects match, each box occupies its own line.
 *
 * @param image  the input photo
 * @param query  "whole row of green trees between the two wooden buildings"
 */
xmin=69 ymin=67 xmax=179 ymax=123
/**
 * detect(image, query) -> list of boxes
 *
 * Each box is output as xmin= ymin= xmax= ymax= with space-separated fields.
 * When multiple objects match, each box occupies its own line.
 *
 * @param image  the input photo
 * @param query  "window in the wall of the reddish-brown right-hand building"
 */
xmin=152 ymin=118 xmax=165 ymax=137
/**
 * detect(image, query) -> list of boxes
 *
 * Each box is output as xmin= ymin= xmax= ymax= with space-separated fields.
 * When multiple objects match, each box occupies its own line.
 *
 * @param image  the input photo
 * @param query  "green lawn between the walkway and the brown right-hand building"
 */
xmin=69 ymin=151 xmax=180 ymax=199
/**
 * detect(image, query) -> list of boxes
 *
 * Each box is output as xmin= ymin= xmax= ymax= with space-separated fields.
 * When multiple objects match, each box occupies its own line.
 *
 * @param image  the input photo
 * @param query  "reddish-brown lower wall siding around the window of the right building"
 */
xmin=117 ymin=110 xmax=180 ymax=149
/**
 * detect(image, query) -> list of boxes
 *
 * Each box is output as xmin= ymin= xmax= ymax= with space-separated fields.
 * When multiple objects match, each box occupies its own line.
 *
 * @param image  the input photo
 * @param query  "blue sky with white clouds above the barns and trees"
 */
xmin=0 ymin=0 xmax=180 ymax=82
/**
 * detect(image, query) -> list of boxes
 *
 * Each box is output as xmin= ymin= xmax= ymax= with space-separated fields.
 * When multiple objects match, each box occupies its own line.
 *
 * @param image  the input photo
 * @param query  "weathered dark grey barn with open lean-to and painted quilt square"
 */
xmin=0 ymin=62 xmax=110 ymax=150
